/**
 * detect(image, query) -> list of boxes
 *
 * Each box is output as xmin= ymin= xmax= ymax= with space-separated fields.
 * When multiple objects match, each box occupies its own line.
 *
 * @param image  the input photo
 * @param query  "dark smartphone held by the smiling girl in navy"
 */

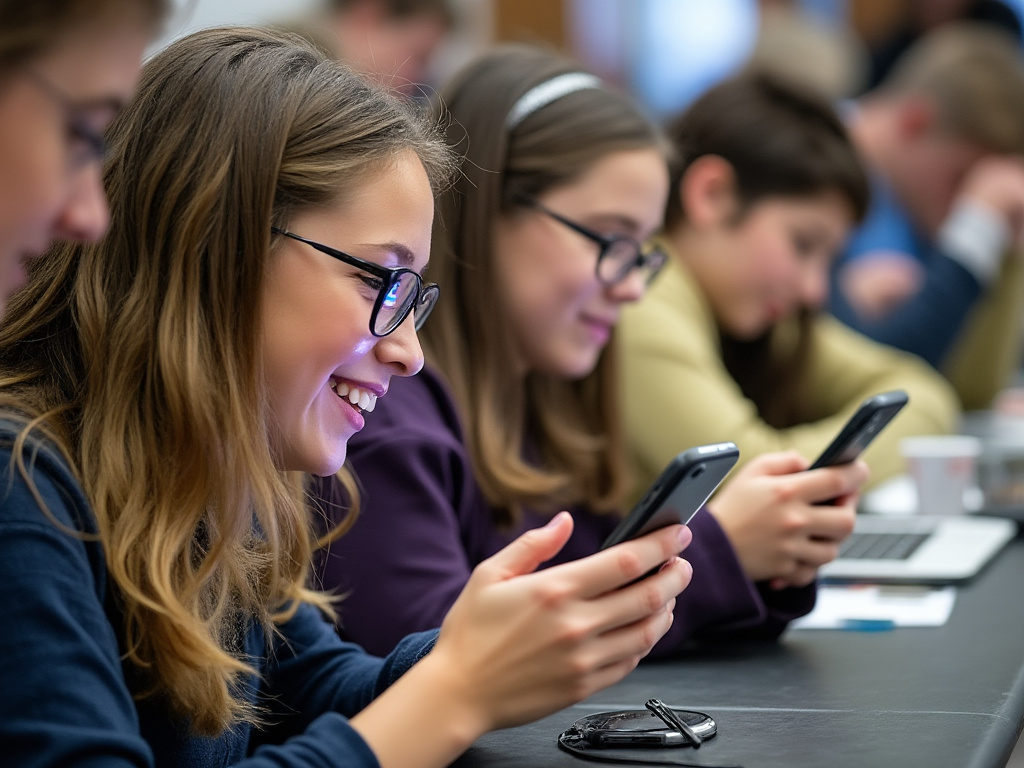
xmin=601 ymin=442 xmax=739 ymax=549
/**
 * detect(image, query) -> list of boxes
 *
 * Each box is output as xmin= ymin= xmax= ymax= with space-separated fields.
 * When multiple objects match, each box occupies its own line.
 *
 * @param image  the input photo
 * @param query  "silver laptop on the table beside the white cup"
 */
xmin=818 ymin=513 xmax=1017 ymax=584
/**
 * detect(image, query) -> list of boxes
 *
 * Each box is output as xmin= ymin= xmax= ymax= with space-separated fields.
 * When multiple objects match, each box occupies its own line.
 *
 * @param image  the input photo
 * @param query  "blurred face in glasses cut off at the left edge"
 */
xmin=0 ymin=0 xmax=169 ymax=315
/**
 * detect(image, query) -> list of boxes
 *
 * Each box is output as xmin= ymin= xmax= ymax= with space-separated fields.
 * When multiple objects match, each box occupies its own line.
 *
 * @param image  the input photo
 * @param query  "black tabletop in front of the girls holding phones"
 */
xmin=456 ymin=538 xmax=1024 ymax=768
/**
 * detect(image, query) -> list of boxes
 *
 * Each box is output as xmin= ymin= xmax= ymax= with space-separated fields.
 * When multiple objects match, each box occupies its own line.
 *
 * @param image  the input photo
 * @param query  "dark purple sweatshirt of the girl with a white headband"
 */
xmin=313 ymin=368 xmax=815 ymax=655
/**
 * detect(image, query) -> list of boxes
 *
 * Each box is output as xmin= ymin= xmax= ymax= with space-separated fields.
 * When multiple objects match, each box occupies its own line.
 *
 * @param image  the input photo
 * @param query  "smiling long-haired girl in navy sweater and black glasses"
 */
xmin=0 ymin=30 xmax=689 ymax=768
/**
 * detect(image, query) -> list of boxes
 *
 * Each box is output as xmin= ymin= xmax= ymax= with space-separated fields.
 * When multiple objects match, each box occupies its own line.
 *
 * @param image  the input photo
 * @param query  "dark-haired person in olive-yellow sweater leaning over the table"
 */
xmin=618 ymin=73 xmax=956 ymax=499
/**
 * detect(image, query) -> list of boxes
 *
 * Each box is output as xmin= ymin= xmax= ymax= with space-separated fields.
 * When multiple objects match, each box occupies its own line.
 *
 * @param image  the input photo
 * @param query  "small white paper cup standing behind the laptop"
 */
xmin=900 ymin=434 xmax=981 ymax=515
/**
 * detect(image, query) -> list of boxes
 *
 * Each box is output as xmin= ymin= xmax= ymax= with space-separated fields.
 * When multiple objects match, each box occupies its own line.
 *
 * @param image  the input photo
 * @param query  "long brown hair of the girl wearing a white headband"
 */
xmin=421 ymin=45 xmax=669 ymax=525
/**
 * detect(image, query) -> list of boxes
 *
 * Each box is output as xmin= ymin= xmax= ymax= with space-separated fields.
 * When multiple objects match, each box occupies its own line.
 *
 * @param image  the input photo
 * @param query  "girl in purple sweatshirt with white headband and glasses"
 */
xmin=321 ymin=41 xmax=865 ymax=652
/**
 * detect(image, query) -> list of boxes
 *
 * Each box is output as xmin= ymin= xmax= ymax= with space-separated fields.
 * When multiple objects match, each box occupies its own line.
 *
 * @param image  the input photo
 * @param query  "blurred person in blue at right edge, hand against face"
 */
xmin=830 ymin=24 xmax=1024 ymax=409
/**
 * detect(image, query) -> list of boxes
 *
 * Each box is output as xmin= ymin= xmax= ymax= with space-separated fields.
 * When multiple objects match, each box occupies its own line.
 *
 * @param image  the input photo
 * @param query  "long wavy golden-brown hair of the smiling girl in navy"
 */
xmin=0 ymin=29 xmax=451 ymax=734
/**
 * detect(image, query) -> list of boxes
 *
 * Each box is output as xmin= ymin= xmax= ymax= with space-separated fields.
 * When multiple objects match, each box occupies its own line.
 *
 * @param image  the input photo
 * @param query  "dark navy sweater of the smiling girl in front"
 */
xmin=0 ymin=425 xmax=436 ymax=768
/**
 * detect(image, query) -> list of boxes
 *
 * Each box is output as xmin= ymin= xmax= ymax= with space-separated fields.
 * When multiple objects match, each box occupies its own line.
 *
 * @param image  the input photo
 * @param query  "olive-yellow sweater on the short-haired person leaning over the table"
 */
xmin=617 ymin=255 xmax=959 ymax=496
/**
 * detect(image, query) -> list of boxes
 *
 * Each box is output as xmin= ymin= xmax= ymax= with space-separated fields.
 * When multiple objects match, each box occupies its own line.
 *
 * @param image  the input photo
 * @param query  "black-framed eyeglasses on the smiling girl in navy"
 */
xmin=270 ymin=226 xmax=441 ymax=336
